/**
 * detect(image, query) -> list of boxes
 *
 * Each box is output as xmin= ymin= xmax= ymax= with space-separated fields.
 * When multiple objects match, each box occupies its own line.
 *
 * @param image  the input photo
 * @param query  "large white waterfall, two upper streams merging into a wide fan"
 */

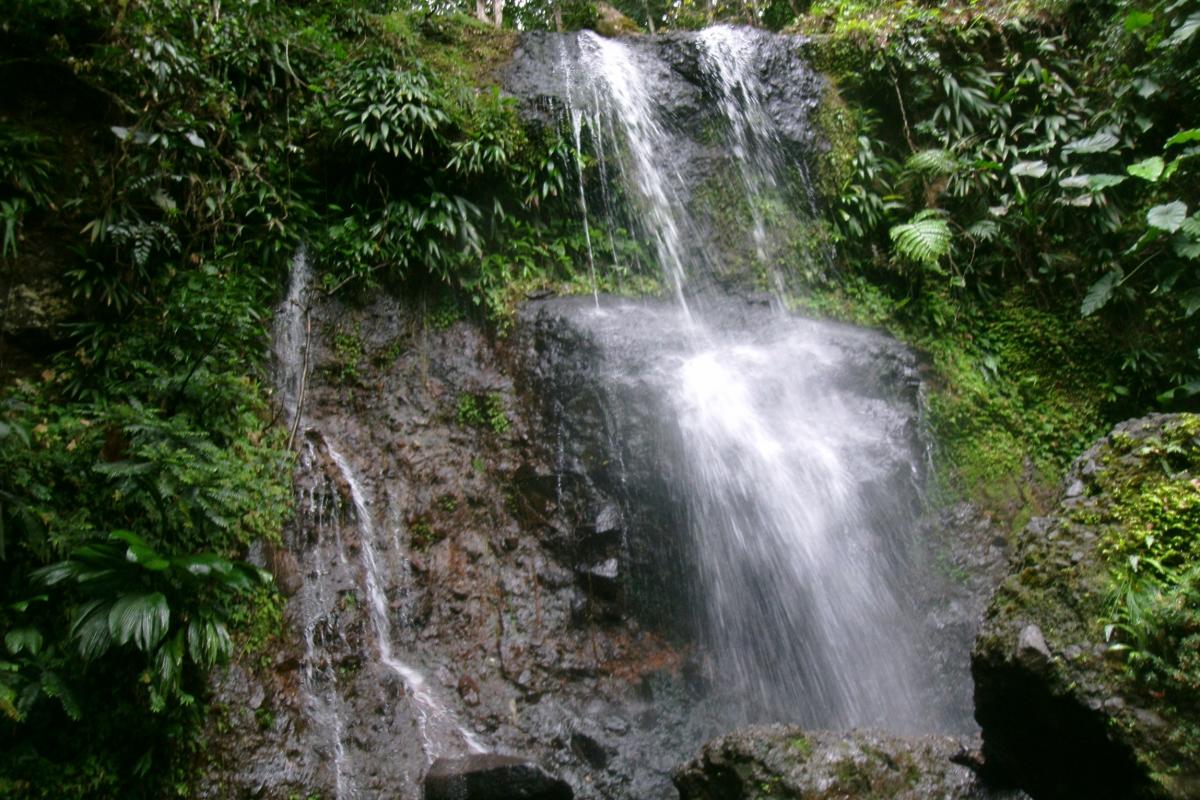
xmin=506 ymin=26 xmax=947 ymax=732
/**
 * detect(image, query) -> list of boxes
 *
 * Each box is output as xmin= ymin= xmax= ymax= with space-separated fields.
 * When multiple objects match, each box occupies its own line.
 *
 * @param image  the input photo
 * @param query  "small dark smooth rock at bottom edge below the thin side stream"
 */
xmin=425 ymin=753 xmax=575 ymax=800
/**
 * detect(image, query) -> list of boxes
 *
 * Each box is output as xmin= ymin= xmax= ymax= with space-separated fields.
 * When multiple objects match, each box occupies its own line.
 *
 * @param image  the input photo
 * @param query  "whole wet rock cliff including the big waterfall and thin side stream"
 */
xmin=250 ymin=28 xmax=972 ymax=800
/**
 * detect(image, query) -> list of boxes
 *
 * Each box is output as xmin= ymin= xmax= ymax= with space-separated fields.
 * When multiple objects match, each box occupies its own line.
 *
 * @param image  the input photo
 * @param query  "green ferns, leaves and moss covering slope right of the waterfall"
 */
xmin=793 ymin=0 xmax=1200 ymax=523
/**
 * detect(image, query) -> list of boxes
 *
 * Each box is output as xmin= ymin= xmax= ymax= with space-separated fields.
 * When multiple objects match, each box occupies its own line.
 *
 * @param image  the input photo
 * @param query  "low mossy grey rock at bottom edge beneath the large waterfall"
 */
xmin=674 ymin=726 xmax=1024 ymax=800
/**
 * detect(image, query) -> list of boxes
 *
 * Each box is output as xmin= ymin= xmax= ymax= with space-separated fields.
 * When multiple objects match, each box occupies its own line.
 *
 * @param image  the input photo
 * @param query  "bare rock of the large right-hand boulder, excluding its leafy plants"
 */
xmin=972 ymin=415 xmax=1200 ymax=800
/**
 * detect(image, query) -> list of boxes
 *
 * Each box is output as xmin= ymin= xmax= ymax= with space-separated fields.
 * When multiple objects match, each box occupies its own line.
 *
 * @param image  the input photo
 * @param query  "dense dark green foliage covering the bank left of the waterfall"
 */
xmin=0 ymin=0 xmax=600 ymax=798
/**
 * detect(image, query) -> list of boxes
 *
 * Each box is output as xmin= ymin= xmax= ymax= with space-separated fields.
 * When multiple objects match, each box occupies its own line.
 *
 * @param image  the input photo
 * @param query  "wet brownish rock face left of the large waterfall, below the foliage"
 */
xmin=197 ymin=293 xmax=716 ymax=800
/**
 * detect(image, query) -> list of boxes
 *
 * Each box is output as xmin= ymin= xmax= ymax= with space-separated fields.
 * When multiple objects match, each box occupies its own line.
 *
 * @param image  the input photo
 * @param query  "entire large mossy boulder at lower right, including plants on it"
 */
xmin=972 ymin=415 xmax=1200 ymax=800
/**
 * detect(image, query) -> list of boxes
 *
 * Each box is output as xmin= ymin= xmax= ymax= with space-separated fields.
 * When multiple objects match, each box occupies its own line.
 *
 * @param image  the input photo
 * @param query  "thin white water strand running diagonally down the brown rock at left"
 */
xmin=325 ymin=440 xmax=487 ymax=762
